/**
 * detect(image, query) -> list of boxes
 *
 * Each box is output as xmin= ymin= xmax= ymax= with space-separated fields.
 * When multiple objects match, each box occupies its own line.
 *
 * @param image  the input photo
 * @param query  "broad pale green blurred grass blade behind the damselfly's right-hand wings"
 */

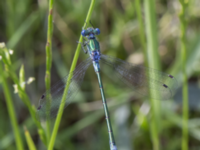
xmin=144 ymin=0 xmax=160 ymax=150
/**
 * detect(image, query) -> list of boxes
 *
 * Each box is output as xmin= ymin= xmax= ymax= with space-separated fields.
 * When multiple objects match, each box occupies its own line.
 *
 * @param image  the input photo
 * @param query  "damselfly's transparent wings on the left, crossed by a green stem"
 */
xmin=37 ymin=58 xmax=92 ymax=119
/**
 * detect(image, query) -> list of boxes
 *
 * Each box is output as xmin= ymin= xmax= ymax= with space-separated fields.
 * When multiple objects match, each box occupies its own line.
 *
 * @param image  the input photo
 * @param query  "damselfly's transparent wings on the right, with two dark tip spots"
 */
xmin=101 ymin=55 xmax=177 ymax=99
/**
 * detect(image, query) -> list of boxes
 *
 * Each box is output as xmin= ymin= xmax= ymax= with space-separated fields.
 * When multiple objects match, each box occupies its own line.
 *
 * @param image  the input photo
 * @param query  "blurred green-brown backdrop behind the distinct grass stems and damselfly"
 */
xmin=0 ymin=0 xmax=200 ymax=150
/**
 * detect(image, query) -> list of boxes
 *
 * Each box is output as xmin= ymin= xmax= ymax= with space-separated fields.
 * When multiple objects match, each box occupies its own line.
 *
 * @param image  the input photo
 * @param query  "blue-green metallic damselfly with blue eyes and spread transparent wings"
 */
xmin=37 ymin=27 xmax=177 ymax=150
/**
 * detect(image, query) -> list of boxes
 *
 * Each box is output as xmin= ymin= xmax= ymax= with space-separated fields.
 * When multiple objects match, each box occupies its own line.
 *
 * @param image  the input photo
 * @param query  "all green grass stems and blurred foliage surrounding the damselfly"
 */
xmin=0 ymin=0 xmax=200 ymax=150
